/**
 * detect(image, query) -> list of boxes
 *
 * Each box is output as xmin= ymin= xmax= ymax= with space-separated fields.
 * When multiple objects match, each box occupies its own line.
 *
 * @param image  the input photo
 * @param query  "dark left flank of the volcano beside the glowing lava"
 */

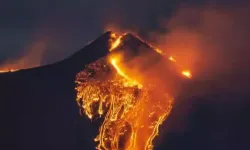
xmin=0 ymin=32 xmax=110 ymax=150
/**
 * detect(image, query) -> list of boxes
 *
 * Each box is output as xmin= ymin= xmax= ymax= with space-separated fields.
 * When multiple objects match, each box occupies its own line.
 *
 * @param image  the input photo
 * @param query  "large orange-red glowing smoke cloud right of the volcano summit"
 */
xmin=151 ymin=3 xmax=250 ymax=78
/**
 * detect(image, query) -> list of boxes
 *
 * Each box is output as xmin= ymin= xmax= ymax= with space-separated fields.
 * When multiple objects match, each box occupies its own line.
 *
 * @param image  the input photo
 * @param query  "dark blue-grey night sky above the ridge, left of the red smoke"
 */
xmin=0 ymin=0 xmax=246 ymax=67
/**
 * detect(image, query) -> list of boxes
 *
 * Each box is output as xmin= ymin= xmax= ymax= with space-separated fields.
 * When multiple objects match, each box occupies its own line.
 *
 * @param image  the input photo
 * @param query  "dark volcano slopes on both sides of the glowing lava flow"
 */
xmin=0 ymin=32 xmax=250 ymax=150
